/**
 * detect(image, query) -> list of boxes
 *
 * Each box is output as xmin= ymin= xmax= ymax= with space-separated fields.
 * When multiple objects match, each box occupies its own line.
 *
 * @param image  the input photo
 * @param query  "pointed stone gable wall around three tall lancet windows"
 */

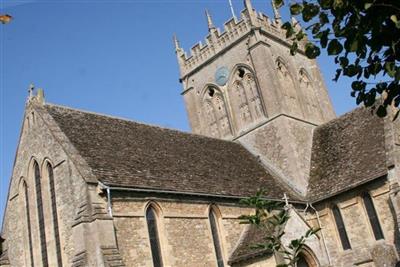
xmin=2 ymin=103 xmax=86 ymax=266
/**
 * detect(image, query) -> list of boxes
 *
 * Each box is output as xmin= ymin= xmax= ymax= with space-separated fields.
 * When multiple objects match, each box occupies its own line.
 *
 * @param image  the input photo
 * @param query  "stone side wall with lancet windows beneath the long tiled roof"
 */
xmin=112 ymin=197 xmax=250 ymax=267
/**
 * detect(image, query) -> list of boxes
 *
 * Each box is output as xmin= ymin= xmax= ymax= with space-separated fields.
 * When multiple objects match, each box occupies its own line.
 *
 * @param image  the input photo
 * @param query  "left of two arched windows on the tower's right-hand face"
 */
xmin=276 ymin=60 xmax=302 ymax=119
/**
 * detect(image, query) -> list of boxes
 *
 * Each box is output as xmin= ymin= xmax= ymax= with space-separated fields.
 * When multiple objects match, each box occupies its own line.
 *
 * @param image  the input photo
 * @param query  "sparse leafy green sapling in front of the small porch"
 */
xmin=239 ymin=191 xmax=320 ymax=267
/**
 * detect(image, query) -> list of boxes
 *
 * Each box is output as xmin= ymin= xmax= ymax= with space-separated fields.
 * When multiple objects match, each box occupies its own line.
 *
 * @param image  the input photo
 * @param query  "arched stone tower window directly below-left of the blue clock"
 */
xmin=203 ymin=87 xmax=232 ymax=137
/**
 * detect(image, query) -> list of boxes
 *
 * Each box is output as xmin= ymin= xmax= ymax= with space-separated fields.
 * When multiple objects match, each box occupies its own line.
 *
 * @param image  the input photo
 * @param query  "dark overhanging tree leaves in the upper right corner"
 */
xmin=274 ymin=0 xmax=400 ymax=118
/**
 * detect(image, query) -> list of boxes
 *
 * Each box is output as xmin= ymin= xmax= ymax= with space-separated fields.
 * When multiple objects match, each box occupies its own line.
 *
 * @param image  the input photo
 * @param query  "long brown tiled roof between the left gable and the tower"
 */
xmin=44 ymin=105 xmax=296 ymax=199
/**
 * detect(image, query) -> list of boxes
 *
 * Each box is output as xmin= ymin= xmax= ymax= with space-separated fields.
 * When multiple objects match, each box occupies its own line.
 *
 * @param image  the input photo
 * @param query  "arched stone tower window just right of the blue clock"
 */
xmin=229 ymin=66 xmax=265 ymax=130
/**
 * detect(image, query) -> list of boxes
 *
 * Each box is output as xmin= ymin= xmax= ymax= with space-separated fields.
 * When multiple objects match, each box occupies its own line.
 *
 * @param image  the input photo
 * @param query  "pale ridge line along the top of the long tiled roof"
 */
xmin=44 ymin=103 xmax=238 ymax=144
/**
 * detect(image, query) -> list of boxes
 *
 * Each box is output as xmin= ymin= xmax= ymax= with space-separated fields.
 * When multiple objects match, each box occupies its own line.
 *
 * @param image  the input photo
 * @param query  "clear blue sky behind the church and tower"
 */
xmin=0 ymin=0 xmax=355 ymax=221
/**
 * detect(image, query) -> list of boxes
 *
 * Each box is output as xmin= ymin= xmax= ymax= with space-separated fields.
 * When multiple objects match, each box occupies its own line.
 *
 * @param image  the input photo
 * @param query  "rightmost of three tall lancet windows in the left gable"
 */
xmin=47 ymin=163 xmax=62 ymax=266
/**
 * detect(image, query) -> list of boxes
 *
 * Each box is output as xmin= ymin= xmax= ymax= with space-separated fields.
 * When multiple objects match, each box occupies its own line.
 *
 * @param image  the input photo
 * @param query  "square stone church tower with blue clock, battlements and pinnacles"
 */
xmin=174 ymin=0 xmax=335 ymax=197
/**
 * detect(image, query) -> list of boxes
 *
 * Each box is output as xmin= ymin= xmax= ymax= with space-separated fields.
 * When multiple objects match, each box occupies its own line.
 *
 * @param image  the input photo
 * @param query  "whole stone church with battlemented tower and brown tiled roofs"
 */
xmin=0 ymin=0 xmax=400 ymax=267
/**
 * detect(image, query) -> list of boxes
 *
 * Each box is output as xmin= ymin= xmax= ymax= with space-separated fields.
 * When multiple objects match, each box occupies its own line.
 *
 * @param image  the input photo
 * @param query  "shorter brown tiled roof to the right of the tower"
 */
xmin=308 ymin=108 xmax=387 ymax=200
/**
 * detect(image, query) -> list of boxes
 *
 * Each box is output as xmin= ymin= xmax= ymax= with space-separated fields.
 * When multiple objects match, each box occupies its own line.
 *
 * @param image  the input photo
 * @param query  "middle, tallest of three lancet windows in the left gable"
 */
xmin=33 ymin=161 xmax=48 ymax=267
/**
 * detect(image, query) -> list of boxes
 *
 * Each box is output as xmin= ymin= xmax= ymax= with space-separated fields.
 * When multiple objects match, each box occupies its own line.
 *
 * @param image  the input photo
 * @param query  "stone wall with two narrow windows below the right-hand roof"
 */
xmin=308 ymin=179 xmax=397 ymax=266
